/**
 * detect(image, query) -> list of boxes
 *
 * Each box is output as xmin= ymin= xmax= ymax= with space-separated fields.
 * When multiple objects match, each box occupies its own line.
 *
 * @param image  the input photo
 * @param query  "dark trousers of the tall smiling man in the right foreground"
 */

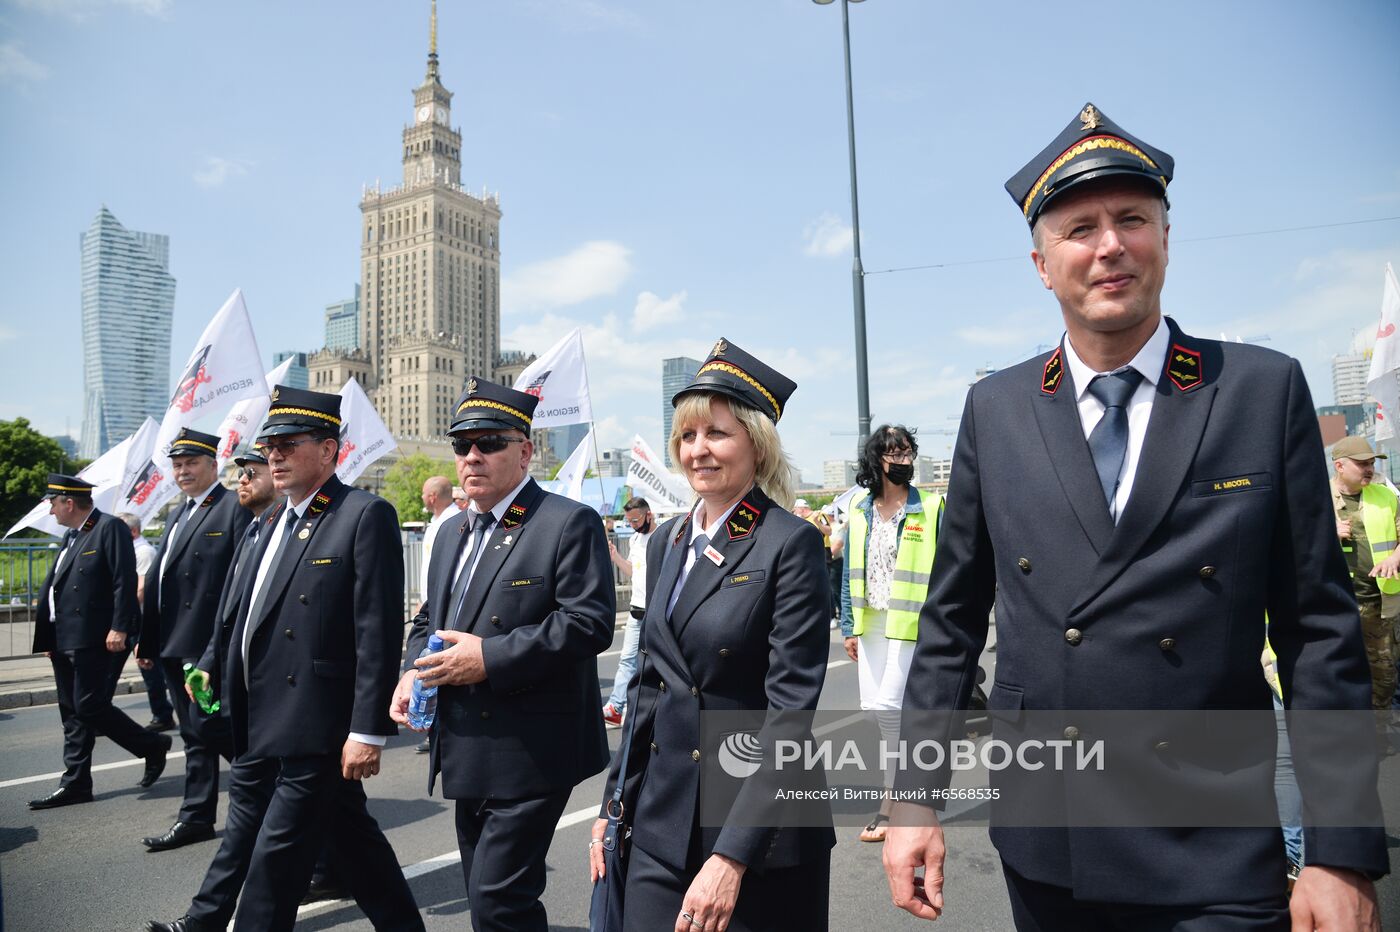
xmin=1001 ymin=862 xmax=1291 ymax=932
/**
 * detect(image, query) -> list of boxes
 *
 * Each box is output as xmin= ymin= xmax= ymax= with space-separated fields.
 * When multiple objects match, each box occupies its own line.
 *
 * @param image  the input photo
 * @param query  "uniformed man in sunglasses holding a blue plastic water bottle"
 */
xmin=392 ymin=378 xmax=616 ymax=932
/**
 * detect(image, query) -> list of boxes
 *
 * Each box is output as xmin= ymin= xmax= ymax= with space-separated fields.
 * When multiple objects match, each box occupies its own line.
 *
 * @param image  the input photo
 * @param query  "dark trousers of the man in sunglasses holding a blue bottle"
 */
xmin=456 ymin=789 xmax=568 ymax=932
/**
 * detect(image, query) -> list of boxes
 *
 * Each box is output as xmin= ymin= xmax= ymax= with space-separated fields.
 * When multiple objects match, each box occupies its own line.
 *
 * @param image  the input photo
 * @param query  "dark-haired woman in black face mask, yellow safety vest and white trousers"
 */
xmin=841 ymin=424 xmax=944 ymax=842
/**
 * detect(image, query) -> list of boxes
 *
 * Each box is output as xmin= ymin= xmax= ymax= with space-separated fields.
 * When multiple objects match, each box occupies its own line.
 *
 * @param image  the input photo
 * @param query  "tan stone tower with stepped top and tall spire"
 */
xmin=350 ymin=4 xmax=501 ymax=441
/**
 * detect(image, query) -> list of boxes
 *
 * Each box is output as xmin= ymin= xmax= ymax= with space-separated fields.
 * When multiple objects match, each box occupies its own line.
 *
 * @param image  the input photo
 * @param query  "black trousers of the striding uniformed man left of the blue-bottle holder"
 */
xmin=189 ymin=754 xmax=423 ymax=932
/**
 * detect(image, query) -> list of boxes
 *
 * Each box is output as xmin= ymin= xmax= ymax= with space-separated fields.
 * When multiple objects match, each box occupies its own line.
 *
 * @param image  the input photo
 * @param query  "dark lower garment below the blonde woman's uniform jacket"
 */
xmin=622 ymin=845 xmax=832 ymax=932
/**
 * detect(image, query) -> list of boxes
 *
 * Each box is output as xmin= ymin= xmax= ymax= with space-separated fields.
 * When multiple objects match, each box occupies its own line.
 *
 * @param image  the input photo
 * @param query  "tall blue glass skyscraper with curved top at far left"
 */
xmin=78 ymin=206 xmax=175 ymax=459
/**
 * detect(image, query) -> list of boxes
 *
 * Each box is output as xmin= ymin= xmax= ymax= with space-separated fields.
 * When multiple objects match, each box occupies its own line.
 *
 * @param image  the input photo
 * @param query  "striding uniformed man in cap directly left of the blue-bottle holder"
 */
xmin=147 ymin=385 xmax=423 ymax=932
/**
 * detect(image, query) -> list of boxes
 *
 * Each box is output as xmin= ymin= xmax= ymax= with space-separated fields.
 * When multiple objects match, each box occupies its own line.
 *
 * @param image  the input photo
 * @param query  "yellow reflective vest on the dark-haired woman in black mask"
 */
xmin=846 ymin=488 xmax=944 ymax=641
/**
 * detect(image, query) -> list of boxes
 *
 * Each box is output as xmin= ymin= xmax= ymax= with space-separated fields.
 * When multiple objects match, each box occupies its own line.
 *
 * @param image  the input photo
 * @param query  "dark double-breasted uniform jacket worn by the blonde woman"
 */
xmin=603 ymin=487 xmax=836 ymax=872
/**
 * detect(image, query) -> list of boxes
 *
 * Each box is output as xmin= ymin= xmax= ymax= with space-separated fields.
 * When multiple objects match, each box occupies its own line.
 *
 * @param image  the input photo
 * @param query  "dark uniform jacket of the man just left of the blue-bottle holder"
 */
xmin=216 ymin=476 xmax=403 ymax=758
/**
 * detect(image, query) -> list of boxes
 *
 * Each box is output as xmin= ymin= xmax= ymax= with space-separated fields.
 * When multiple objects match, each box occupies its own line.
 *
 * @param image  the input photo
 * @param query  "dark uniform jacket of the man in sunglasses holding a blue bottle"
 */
xmin=405 ymin=480 xmax=617 ymax=799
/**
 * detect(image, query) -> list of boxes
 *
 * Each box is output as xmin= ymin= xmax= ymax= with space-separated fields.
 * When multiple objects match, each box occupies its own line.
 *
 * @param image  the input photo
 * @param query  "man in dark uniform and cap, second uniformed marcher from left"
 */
xmin=136 ymin=427 xmax=251 ymax=851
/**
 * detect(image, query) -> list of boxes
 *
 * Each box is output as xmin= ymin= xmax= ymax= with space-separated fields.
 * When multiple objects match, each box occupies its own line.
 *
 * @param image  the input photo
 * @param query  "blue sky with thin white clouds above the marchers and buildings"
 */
xmin=0 ymin=0 xmax=1400 ymax=480
